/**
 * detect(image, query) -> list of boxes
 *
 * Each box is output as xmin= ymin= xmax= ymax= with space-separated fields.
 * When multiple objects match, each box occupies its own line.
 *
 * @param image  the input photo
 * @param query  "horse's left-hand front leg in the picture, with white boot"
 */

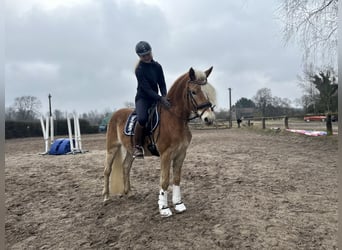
xmin=158 ymin=153 xmax=172 ymax=217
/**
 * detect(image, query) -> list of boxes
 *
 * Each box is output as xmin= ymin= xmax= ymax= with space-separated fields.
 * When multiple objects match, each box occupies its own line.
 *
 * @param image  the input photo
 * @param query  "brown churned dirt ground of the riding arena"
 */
xmin=5 ymin=128 xmax=338 ymax=249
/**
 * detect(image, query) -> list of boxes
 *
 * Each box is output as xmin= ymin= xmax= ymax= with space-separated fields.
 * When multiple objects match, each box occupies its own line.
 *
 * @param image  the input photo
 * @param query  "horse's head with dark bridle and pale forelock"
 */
xmin=187 ymin=67 xmax=216 ymax=125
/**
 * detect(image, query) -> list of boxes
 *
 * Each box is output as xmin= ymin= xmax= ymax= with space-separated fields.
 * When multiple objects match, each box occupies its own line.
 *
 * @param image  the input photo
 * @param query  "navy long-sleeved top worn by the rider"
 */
xmin=135 ymin=60 xmax=167 ymax=101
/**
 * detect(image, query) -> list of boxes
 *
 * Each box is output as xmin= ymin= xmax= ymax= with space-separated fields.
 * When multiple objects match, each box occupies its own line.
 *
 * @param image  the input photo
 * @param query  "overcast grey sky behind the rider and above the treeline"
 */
xmin=5 ymin=0 xmax=302 ymax=113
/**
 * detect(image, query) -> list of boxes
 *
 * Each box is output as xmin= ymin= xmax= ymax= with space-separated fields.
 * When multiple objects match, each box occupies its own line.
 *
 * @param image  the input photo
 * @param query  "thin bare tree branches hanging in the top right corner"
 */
xmin=279 ymin=0 xmax=338 ymax=65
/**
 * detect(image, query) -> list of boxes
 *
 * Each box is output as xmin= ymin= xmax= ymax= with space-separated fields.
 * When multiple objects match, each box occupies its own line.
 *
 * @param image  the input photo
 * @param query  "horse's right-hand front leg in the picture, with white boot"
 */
xmin=172 ymin=150 xmax=186 ymax=213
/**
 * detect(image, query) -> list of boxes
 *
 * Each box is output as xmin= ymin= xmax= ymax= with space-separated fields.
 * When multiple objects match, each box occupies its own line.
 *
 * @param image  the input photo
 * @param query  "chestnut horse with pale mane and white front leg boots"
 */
xmin=102 ymin=67 xmax=216 ymax=217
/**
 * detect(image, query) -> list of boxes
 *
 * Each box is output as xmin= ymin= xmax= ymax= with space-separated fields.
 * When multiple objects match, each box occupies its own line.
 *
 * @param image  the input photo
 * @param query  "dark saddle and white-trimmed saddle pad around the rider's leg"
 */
xmin=124 ymin=104 xmax=160 ymax=156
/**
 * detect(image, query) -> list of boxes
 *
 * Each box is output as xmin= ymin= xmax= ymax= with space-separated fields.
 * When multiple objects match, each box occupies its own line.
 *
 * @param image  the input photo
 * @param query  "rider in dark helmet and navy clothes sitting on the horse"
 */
xmin=133 ymin=41 xmax=171 ymax=158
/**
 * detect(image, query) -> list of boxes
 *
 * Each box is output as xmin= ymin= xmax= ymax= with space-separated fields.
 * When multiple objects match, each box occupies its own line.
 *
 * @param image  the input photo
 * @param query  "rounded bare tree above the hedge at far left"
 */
xmin=12 ymin=96 xmax=42 ymax=121
